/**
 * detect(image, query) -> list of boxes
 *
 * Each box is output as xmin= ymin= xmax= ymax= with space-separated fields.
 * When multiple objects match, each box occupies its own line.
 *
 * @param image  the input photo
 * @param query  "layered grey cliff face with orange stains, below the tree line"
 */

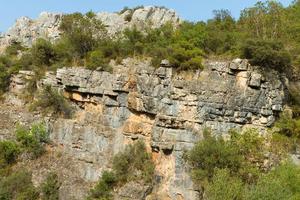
xmin=6 ymin=59 xmax=285 ymax=200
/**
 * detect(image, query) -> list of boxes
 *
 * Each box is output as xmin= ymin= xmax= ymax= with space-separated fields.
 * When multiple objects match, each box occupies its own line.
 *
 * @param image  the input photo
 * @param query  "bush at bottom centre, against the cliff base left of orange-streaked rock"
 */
xmin=88 ymin=141 xmax=154 ymax=200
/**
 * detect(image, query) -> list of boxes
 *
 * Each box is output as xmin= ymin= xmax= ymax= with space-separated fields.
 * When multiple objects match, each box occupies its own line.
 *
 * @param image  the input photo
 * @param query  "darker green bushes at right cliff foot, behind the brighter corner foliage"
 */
xmin=185 ymin=129 xmax=289 ymax=187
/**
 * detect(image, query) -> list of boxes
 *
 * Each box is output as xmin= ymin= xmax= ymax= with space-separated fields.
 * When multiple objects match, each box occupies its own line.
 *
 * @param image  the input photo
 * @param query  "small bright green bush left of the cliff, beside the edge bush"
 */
xmin=16 ymin=124 xmax=49 ymax=158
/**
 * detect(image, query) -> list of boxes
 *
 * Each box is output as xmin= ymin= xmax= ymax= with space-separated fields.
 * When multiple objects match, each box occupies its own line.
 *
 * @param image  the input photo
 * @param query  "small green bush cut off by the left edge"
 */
xmin=0 ymin=141 xmax=20 ymax=167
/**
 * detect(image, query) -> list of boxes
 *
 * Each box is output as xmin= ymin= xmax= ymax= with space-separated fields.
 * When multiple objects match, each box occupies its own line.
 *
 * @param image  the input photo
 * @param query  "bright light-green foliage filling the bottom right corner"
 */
xmin=205 ymin=162 xmax=300 ymax=200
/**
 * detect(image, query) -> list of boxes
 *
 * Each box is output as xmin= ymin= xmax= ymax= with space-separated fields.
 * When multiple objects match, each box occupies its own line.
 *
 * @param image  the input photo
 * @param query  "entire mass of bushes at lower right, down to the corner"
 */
xmin=185 ymin=129 xmax=300 ymax=200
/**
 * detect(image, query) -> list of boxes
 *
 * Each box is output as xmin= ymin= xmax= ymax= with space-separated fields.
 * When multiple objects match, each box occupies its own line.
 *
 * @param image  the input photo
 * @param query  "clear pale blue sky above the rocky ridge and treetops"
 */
xmin=0 ymin=0 xmax=292 ymax=32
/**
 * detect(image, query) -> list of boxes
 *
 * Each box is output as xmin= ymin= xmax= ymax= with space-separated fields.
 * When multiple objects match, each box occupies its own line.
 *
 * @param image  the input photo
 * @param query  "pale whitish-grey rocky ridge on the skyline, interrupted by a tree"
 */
xmin=0 ymin=6 xmax=181 ymax=52
